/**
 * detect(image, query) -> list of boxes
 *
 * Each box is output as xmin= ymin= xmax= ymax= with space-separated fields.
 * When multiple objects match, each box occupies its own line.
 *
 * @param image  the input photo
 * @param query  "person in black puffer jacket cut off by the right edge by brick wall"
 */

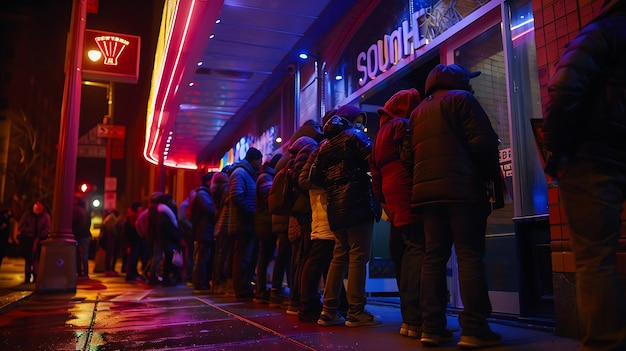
xmin=543 ymin=0 xmax=626 ymax=350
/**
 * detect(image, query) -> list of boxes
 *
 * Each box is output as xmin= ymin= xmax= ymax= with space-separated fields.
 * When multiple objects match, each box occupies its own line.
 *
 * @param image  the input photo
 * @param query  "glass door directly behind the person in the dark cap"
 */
xmin=443 ymin=16 xmax=520 ymax=314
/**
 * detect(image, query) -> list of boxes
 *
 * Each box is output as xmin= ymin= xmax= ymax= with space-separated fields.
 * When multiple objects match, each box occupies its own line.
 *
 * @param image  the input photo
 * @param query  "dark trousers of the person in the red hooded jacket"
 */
xmin=395 ymin=221 xmax=424 ymax=326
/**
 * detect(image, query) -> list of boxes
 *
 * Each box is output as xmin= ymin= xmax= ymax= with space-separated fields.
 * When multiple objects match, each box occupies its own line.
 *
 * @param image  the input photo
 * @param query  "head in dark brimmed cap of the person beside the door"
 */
xmin=426 ymin=64 xmax=480 ymax=95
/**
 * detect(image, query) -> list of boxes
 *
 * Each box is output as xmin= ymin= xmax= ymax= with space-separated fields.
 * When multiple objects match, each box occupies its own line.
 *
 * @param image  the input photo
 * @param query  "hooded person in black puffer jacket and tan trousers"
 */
xmin=310 ymin=105 xmax=381 ymax=327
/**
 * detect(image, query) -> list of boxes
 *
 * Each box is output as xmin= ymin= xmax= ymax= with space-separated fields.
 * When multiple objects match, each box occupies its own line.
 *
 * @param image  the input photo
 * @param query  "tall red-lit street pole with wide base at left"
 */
xmin=35 ymin=0 xmax=87 ymax=292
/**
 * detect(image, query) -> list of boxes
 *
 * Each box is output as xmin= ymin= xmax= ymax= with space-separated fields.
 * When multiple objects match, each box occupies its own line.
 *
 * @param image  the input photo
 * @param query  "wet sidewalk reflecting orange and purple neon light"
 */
xmin=0 ymin=258 xmax=580 ymax=351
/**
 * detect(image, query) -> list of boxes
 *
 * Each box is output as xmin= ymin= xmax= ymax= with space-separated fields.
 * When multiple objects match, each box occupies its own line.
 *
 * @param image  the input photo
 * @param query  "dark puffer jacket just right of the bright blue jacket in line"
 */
xmin=254 ymin=163 xmax=275 ymax=239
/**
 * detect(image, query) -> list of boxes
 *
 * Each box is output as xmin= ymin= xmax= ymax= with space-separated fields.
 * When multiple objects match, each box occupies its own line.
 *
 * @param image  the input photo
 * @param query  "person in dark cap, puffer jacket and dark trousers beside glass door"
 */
xmin=409 ymin=64 xmax=502 ymax=348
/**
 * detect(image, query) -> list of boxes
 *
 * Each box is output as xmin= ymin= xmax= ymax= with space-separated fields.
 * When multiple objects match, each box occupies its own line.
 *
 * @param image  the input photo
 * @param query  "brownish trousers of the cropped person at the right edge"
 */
xmin=559 ymin=160 xmax=626 ymax=350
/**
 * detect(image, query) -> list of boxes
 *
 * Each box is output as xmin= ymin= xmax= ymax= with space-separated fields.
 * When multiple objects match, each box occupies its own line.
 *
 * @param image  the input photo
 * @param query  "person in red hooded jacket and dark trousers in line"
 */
xmin=369 ymin=89 xmax=424 ymax=338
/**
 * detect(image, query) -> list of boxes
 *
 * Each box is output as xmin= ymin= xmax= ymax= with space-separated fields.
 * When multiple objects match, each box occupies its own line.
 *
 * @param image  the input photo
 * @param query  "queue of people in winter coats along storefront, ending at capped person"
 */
xmin=150 ymin=64 xmax=501 ymax=348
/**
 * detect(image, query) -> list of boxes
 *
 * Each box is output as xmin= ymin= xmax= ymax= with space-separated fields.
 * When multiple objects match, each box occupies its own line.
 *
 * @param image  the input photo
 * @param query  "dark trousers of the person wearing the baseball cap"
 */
xmin=421 ymin=203 xmax=491 ymax=335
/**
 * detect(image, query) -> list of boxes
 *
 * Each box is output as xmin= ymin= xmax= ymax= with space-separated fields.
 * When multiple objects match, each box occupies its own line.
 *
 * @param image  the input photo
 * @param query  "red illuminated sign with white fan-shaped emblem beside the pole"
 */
xmin=83 ymin=29 xmax=141 ymax=83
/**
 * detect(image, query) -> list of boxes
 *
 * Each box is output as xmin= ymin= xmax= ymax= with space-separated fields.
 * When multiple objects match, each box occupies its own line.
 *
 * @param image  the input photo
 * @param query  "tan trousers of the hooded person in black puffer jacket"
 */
xmin=324 ymin=220 xmax=374 ymax=315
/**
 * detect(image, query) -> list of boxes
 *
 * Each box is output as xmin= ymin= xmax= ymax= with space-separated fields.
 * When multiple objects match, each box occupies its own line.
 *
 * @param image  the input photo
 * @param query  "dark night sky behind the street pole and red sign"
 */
xmin=0 ymin=0 xmax=163 ymax=210
